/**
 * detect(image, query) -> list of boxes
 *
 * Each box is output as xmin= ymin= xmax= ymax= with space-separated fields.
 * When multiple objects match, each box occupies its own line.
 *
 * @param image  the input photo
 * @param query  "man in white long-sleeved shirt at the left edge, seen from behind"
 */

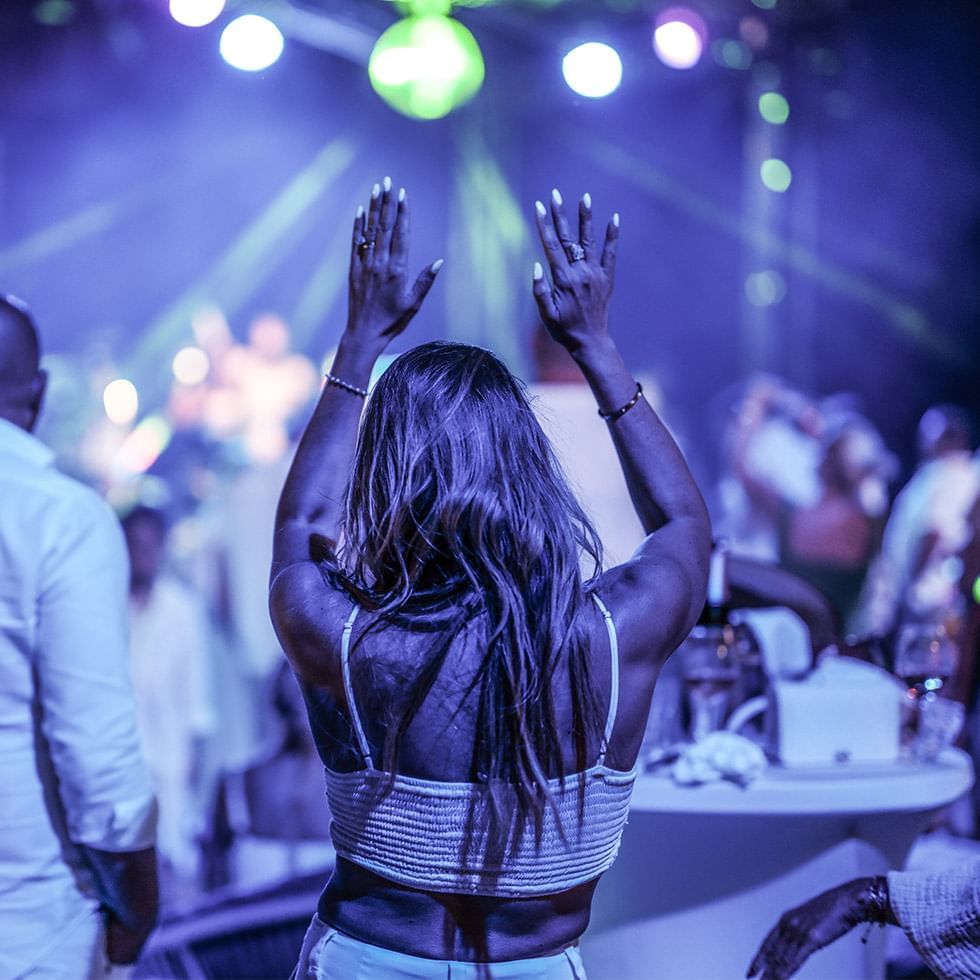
xmin=0 ymin=294 xmax=157 ymax=980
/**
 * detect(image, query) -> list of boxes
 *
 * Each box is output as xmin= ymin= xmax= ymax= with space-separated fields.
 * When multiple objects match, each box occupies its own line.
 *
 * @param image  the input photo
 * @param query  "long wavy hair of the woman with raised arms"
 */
xmin=331 ymin=342 xmax=601 ymax=843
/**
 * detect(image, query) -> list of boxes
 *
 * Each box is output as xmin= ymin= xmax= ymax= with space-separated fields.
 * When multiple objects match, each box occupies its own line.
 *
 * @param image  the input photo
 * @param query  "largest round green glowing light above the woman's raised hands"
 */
xmin=368 ymin=15 xmax=484 ymax=119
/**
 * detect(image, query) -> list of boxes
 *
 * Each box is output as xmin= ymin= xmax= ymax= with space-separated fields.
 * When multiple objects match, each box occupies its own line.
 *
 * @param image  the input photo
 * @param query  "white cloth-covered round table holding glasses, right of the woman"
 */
xmin=582 ymin=750 xmax=973 ymax=980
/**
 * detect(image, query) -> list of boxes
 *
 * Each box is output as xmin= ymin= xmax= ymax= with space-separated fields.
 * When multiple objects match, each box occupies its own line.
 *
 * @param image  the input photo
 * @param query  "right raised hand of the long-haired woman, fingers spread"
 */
xmin=533 ymin=190 xmax=619 ymax=353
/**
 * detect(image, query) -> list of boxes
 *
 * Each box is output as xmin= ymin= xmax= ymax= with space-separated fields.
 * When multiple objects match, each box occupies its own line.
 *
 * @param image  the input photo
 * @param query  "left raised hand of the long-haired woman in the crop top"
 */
xmin=346 ymin=177 xmax=442 ymax=354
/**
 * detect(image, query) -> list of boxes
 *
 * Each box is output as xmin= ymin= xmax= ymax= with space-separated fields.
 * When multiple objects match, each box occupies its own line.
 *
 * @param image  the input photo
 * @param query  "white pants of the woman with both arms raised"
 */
xmin=291 ymin=915 xmax=586 ymax=980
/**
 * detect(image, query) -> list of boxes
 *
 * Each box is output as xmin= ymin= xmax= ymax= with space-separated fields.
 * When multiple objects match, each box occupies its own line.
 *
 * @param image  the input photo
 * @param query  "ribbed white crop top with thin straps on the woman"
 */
xmin=326 ymin=595 xmax=636 ymax=897
